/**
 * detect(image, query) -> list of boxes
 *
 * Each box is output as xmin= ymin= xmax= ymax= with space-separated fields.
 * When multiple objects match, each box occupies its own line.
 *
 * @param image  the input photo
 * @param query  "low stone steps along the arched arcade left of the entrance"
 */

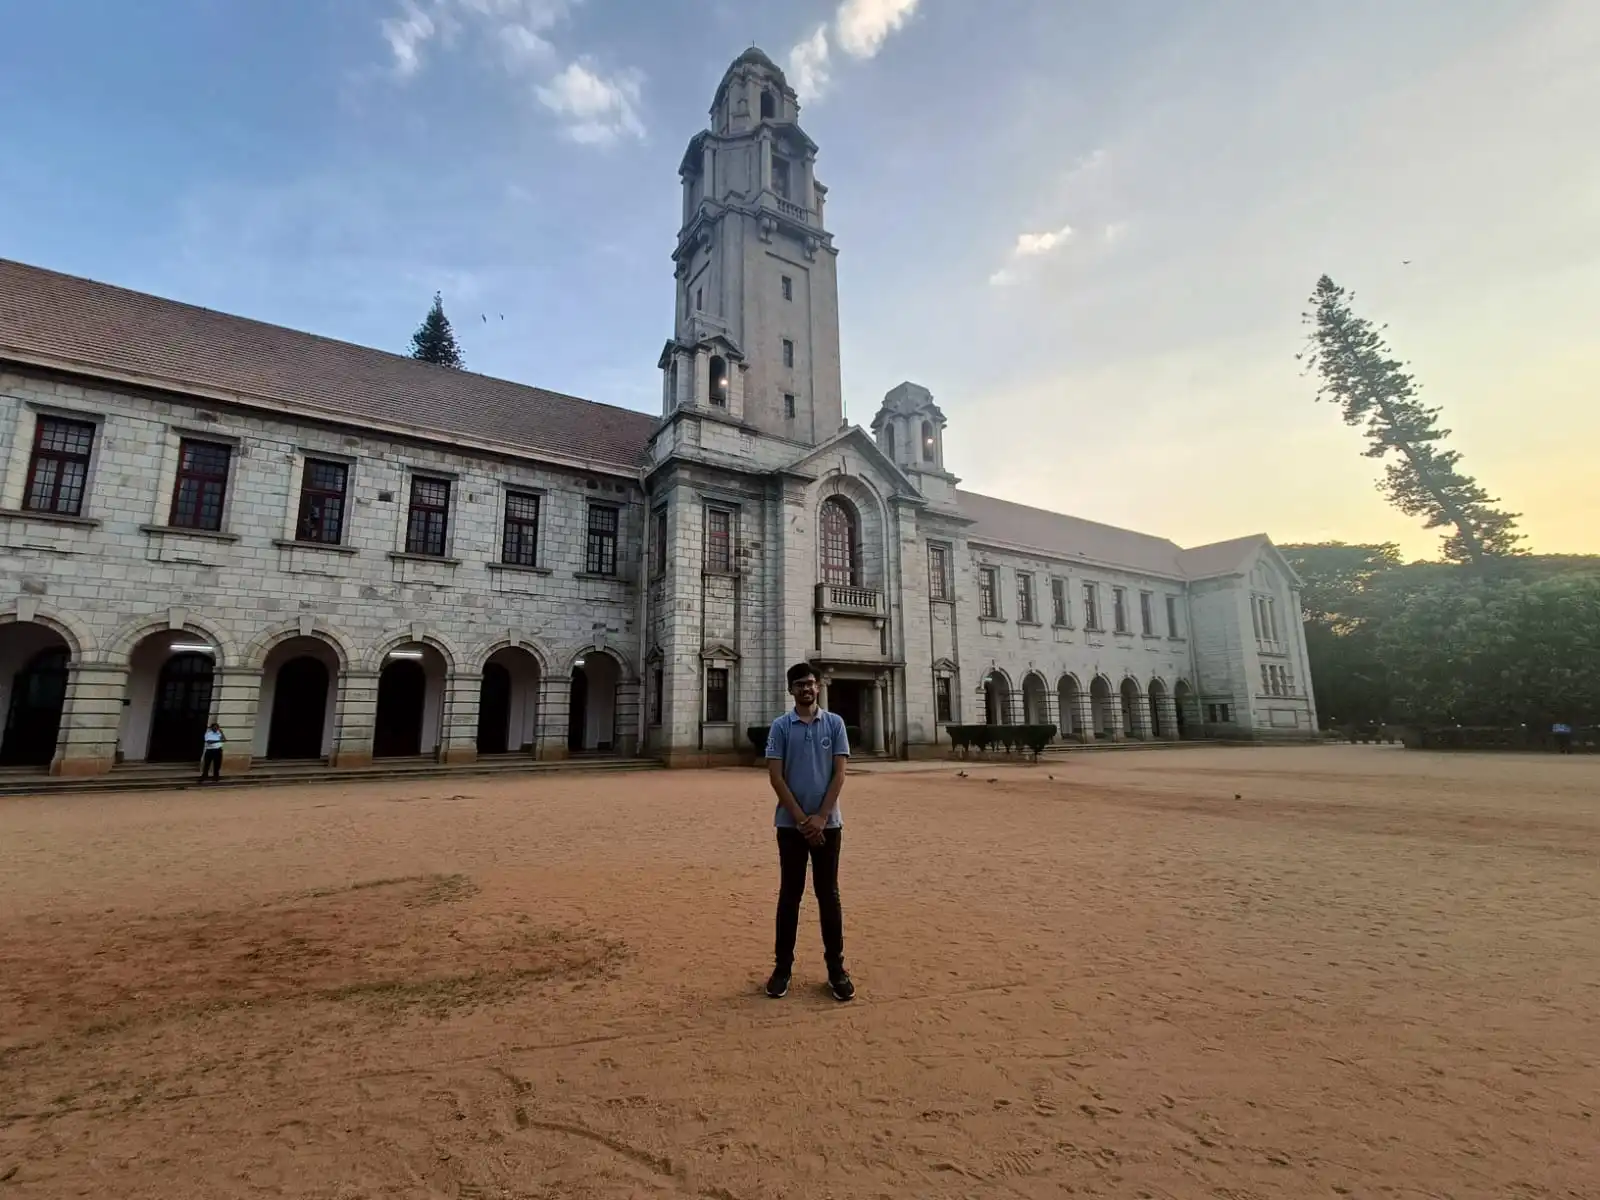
xmin=0 ymin=754 xmax=661 ymax=797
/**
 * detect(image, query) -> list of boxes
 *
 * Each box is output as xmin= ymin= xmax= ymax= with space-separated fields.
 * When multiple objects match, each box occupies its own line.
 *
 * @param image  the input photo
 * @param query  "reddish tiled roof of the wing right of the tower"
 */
xmin=957 ymin=491 xmax=1266 ymax=579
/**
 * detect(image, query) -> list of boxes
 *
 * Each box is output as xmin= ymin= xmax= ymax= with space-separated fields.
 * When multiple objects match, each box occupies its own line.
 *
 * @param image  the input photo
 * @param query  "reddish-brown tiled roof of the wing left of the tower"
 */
xmin=0 ymin=259 xmax=656 ymax=470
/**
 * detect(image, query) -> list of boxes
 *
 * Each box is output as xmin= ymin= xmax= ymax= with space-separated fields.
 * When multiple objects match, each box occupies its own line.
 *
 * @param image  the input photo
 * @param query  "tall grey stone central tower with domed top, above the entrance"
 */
xmin=661 ymin=46 xmax=843 ymax=445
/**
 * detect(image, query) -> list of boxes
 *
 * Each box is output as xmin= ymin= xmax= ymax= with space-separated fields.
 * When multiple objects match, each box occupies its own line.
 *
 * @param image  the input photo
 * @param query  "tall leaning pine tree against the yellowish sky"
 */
xmin=1299 ymin=275 xmax=1522 ymax=563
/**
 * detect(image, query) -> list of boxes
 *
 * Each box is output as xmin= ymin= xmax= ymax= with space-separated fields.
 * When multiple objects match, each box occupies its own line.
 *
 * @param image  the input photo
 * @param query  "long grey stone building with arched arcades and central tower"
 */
xmin=0 ymin=50 xmax=1315 ymax=774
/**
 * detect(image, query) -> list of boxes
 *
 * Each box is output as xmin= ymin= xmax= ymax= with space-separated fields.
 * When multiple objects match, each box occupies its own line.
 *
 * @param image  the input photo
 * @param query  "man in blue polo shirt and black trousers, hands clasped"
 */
xmin=766 ymin=662 xmax=856 ymax=1000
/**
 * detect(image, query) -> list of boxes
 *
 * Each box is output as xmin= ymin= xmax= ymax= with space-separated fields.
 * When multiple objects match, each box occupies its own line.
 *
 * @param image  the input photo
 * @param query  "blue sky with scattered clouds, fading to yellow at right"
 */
xmin=0 ymin=0 xmax=1600 ymax=557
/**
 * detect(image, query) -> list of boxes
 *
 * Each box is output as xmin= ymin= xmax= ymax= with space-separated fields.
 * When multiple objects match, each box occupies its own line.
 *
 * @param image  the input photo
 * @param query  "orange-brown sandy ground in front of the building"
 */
xmin=0 ymin=747 xmax=1600 ymax=1200
